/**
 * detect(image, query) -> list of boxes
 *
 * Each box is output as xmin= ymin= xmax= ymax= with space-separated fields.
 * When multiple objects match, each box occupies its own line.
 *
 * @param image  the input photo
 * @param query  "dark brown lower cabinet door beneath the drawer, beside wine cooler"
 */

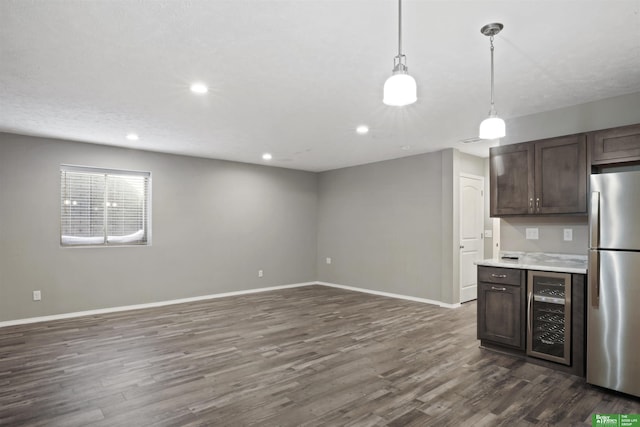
xmin=478 ymin=282 xmax=525 ymax=350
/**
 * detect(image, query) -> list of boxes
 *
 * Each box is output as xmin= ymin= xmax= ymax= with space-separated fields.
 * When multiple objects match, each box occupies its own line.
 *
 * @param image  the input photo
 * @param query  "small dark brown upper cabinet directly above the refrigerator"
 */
xmin=589 ymin=124 xmax=640 ymax=166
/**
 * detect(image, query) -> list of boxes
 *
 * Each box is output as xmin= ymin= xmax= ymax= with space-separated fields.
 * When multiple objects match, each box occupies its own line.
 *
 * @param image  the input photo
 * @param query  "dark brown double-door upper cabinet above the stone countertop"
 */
xmin=490 ymin=134 xmax=587 ymax=217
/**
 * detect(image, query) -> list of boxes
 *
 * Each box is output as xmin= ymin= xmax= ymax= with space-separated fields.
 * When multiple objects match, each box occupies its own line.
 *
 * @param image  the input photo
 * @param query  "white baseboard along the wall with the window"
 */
xmin=0 ymin=282 xmax=318 ymax=328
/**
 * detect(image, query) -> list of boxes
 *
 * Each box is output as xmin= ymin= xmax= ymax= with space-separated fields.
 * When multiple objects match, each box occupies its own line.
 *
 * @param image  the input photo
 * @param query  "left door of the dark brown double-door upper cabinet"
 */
xmin=490 ymin=143 xmax=534 ymax=217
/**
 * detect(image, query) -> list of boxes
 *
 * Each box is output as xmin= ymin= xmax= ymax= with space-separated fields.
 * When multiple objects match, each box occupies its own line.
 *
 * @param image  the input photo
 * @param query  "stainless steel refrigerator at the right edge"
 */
xmin=587 ymin=171 xmax=640 ymax=396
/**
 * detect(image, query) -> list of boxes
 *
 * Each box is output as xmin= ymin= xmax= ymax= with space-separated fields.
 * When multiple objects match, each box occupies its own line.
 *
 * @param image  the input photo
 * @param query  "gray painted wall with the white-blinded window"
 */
xmin=0 ymin=134 xmax=317 ymax=321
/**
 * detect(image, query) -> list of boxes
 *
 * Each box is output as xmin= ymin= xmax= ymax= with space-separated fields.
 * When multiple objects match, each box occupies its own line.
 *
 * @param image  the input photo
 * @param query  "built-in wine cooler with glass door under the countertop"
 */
xmin=527 ymin=270 xmax=571 ymax=365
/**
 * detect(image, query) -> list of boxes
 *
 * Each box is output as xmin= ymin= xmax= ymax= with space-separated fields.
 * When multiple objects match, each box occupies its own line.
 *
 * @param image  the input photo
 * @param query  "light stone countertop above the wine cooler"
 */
xmin=475 ymin=252 xmax=587 ymax=274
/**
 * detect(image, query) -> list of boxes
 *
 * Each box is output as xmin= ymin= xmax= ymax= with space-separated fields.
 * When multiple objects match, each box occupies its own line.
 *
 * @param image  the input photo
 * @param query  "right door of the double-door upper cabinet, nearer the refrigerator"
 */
xmin=534 ymin=134 xmax=587 ymax=214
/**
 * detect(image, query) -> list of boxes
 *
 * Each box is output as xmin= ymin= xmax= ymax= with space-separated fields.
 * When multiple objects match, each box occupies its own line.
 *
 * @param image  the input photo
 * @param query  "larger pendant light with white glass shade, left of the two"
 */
xmin=382 ymin=0 xmax=418 ymax=107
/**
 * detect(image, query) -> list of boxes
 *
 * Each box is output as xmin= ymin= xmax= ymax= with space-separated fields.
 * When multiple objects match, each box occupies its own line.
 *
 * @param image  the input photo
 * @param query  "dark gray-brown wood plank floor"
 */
xmin=0 ymin=286 xmax=640 ymax=427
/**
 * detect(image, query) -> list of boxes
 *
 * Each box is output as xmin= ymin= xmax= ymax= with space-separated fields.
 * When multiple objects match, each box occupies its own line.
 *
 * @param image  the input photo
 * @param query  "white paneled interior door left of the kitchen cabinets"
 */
xmin=460 ymin=174 xmax=484 ymax=302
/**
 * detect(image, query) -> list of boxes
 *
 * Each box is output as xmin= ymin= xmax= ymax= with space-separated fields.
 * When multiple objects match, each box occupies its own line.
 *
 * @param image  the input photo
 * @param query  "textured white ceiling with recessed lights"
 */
xmin=0 ymin=0 xmax=640 ymax=171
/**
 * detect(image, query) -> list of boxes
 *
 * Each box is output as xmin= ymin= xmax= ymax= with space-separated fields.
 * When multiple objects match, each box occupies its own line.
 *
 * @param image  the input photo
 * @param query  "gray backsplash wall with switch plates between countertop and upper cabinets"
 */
xmin=500 ymin=216 xmax=589 ymax=255
